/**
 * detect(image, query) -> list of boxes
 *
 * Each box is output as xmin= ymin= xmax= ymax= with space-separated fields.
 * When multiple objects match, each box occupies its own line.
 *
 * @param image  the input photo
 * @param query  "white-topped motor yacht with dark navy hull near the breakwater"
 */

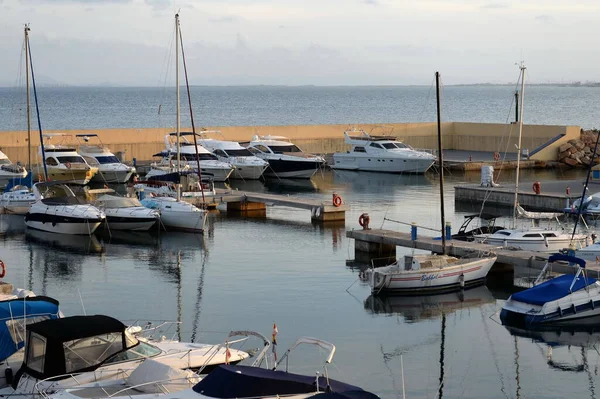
xmin=243 ymin=136 xmax=325 ymax=179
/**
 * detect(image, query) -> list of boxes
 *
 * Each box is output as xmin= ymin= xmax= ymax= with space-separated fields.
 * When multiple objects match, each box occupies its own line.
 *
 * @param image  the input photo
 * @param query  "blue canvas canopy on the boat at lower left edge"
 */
xmin=0 ymin=296 xmax=59 ymax=361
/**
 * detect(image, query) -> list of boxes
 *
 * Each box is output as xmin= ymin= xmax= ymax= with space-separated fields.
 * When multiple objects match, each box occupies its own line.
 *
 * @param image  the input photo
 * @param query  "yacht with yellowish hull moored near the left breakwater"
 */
xmin=37 ymin=133 xmax=98 ymax=185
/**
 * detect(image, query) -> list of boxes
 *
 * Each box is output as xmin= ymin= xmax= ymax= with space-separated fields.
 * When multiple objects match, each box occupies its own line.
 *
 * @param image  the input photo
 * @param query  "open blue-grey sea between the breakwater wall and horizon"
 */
xmin=0 ymin=86 xmax=600 ymax=130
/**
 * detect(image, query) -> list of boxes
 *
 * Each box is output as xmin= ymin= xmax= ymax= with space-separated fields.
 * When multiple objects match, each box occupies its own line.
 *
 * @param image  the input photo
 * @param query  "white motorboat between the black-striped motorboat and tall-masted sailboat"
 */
xmin=90 ymin=190 xmax=160 ymax=231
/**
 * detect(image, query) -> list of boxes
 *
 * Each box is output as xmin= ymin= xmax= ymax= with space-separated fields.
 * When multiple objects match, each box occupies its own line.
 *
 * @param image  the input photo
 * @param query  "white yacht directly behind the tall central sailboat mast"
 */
xmin=146 ymin=132 xmax=233 ymax=182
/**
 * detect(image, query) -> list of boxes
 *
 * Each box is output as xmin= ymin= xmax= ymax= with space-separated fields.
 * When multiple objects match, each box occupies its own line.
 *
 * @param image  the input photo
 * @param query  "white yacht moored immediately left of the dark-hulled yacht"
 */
xmin=198 ymin=130 xmax=269 ymax=180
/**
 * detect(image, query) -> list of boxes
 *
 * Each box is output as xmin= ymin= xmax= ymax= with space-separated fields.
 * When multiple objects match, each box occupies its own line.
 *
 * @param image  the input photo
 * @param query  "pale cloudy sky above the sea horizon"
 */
xmin=0 ymin=0 xmax=600 ymax=86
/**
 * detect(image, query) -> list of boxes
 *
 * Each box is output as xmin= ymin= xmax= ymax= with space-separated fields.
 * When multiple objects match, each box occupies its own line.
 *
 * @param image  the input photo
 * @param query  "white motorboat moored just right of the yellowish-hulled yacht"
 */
xmin=75 ymin=134 xmax=135 ymax=183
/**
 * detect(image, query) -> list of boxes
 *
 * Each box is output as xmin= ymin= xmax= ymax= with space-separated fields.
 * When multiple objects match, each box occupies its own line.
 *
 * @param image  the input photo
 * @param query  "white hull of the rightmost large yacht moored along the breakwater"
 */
xmin=331 ymin=153 xmax=435 ymax=174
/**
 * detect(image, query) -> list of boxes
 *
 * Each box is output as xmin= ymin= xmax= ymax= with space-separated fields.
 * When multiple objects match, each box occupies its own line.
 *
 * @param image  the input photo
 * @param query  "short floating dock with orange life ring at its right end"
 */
xmin=184 ymin=189 xmax=350 ymax=222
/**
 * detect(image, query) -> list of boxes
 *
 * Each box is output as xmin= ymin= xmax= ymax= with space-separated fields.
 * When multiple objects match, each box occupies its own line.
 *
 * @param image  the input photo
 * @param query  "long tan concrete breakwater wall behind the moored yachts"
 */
xmin=0 ymin=122 xmax=580 ymax=163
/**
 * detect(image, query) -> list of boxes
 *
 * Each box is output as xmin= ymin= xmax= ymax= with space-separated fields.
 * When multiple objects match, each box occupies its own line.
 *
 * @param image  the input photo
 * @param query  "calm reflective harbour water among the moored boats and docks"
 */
xmin=0 ymin=172 xmax=600 ymax=398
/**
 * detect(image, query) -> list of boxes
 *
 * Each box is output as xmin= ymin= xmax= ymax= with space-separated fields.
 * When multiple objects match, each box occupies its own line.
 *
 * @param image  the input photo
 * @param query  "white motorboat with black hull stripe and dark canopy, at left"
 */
xmin=25 ymin=182 xmax=105 ymax=235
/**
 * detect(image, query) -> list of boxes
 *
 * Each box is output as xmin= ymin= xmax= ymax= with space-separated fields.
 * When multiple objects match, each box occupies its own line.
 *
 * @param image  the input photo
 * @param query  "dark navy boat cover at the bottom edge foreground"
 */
xmin=193 ymin=365 xmax=377 ymax=399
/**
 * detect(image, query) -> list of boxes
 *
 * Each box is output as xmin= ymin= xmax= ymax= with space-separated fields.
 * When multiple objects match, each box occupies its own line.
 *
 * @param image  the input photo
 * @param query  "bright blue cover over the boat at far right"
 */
xmin=511 ymin=274 xmax=596 ymax=306
